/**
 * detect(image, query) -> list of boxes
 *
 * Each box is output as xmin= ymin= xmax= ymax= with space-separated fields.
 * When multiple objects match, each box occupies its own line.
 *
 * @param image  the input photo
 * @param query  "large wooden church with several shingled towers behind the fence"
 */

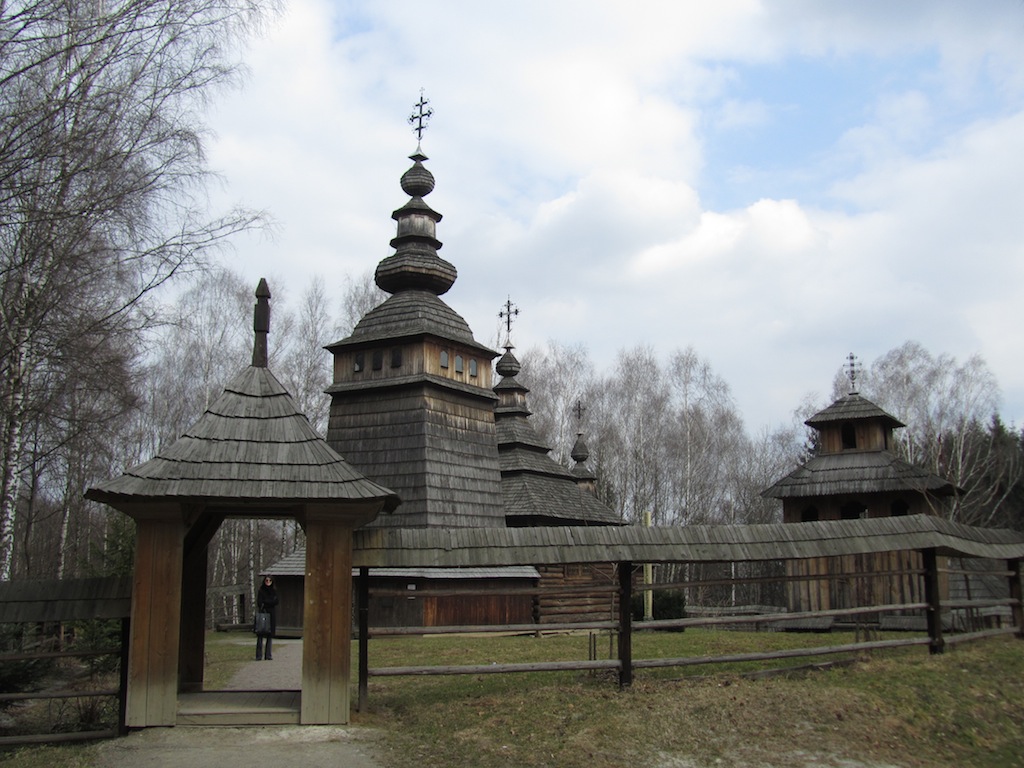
xmin=266 ymin=108 xmax=620 ymax=626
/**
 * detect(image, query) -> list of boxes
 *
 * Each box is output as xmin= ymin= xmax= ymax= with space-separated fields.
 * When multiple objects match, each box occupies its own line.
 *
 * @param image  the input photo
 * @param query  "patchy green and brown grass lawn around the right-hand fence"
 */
xmin=0 ymin=630 xmax=1024 ymax=768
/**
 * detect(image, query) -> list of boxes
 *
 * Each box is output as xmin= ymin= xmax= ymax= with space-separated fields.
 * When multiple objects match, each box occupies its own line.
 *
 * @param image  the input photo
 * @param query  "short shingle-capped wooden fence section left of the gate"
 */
xmin=0 ymin=579 xmax=131 ymax=746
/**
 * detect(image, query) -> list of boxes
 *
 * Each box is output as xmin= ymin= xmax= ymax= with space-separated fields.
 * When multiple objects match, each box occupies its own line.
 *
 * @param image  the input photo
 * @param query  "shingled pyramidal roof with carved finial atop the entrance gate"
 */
xmin=86 ymin=280 xmax=398 ymax=511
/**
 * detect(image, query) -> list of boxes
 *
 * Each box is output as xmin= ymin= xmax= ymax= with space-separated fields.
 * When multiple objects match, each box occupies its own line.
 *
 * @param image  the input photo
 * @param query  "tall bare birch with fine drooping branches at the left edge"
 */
xmin=0 ymin=0 xmax=274 ymax=580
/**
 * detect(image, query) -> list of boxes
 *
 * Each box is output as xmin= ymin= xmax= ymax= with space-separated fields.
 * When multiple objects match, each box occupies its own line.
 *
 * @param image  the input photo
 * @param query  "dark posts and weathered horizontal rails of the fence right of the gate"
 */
xmin=356 ymin=550 xmax=1024 ymax=710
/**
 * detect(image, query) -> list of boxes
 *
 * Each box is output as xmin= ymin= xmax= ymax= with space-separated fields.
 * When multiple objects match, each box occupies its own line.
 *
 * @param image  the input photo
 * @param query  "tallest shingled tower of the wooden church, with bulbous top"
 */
xmin=327 ymin=128 xmax=505 ymax=527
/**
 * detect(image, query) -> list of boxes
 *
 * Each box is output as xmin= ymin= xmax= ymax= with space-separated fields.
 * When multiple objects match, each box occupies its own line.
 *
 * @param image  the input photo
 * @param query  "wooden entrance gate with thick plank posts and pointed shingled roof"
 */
xmin=86 ymin=281 xmax=398 ymax=727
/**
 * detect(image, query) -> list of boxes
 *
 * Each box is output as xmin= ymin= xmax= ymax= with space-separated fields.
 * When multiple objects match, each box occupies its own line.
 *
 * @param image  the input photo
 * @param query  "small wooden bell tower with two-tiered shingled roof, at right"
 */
xmin=762 ymin=367 xmax=961 ymax=610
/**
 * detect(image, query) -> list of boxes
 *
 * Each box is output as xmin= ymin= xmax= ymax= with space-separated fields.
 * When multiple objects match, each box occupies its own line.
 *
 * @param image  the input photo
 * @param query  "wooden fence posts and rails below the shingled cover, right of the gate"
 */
xmin=356 ymin=548 xmax=1024 ymax=711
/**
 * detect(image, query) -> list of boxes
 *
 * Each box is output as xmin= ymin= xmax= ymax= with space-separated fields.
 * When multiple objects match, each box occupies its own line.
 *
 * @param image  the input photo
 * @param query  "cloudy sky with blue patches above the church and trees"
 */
xmin=203 ymin=0 xmax=1024 ymax=431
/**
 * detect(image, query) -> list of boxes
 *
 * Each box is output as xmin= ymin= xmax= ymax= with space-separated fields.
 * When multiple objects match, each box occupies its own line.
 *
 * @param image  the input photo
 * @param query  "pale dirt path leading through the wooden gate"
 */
xmin=93 ymin=640 xmax=381 ymax=768
